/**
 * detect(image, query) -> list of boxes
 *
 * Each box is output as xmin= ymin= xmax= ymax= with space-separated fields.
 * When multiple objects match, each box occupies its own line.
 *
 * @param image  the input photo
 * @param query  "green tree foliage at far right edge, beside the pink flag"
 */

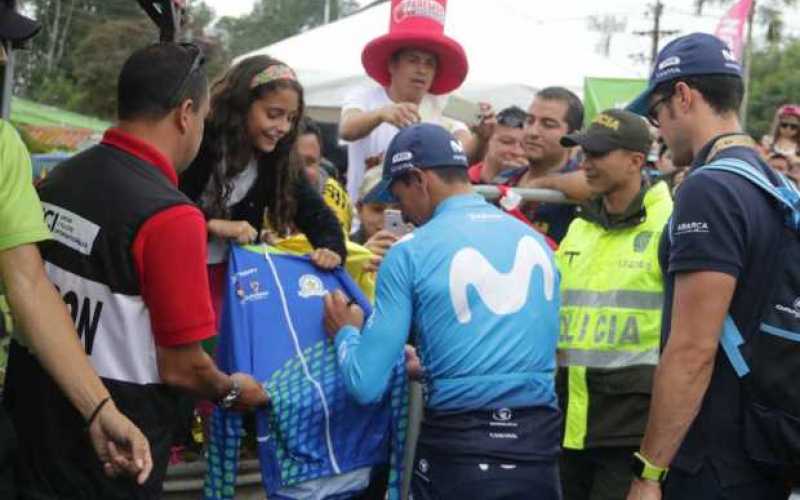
xmin=747 ymin=36 xmax=800 ymax=138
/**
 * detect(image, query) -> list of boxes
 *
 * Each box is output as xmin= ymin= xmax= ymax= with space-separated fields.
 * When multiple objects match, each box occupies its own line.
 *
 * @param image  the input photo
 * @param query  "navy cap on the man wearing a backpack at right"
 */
xmin=627 ymin=33 xmax=742 ymax=115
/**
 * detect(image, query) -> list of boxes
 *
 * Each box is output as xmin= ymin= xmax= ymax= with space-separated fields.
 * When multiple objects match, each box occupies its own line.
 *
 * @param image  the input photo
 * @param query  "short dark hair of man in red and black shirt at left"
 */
xmin=117 ymin=43 xmax=208 ymax=120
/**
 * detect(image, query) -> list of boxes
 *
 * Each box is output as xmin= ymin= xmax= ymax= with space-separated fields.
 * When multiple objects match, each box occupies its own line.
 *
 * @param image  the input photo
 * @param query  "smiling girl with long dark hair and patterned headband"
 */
xmin=181 ymin=56 xmax=346 ymax=312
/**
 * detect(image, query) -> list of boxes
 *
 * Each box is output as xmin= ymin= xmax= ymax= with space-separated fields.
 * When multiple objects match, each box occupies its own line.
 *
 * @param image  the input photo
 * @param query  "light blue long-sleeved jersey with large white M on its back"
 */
xmin=336 ymin=194 xmax=560 ymax=412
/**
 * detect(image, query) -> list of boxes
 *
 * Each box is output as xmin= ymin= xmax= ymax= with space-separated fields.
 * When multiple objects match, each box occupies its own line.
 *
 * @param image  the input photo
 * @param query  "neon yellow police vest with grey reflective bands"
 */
xmin=556 ymin=182 xmax=672 ymax=449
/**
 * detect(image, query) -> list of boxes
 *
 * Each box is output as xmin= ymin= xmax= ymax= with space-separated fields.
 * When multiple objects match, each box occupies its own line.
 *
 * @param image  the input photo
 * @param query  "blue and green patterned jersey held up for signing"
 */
xmin=205 ymin=247 xmax=406 ymax=499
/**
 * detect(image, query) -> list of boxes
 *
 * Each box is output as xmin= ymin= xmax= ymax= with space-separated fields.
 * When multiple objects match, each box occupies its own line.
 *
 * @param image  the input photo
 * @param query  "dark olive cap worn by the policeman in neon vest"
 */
xmin=561 ymin=109 xmax=653 ymax=154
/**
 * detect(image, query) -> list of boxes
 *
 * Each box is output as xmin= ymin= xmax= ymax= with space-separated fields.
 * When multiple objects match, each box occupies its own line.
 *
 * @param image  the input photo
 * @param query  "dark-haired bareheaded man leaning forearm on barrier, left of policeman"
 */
xmin=509 ymin=87 xmax=591 ymax=243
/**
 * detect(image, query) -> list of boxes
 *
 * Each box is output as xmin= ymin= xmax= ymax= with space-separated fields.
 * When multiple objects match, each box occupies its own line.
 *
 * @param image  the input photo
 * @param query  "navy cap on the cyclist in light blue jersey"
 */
xmin=363 ymin=123 xmax=468 ymax=203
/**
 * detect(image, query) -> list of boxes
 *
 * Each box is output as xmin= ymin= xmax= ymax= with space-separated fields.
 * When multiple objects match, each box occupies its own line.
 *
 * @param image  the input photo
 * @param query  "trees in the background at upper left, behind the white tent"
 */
xmin=15 ymin=0 xmax=358 ymax=119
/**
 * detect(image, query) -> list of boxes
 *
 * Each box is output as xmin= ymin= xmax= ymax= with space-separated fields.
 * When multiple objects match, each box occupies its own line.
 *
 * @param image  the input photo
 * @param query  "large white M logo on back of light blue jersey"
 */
xmin=450 ymin=236 xmax=556 ymax=324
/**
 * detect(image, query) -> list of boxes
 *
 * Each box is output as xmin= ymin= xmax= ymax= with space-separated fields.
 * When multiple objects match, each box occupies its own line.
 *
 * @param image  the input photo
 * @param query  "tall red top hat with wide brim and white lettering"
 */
xmin=361 ymin=0 xmax=469 ymax=95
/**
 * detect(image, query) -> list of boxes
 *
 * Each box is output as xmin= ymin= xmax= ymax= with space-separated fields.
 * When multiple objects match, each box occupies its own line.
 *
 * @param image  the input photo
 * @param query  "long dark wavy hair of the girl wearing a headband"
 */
xmin=181 ymin=55 xmax=305 ymax=234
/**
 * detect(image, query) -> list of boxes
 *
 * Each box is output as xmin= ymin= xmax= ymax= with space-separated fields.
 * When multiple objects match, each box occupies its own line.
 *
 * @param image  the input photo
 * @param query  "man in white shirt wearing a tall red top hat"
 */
xmin=339 ymin=0 xmax=493 ymax=203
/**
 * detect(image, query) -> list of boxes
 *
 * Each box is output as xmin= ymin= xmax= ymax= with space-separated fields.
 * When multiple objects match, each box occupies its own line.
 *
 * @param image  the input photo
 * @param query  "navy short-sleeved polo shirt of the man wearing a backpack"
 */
xmin=659 ymin=134 xmax=782 ymax=487
